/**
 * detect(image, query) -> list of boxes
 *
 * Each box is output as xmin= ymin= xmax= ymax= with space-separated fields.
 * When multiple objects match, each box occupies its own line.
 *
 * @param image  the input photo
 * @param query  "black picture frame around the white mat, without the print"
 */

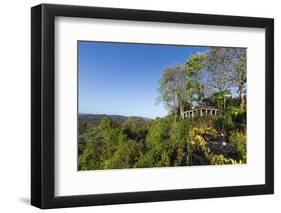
xmin=31 ymin=4 xmax=274 ymax=209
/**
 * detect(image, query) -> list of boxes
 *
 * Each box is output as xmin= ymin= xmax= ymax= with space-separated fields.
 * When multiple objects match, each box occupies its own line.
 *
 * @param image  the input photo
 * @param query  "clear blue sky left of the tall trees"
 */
xmin=78 ymin=41 xmax=207 ymax=118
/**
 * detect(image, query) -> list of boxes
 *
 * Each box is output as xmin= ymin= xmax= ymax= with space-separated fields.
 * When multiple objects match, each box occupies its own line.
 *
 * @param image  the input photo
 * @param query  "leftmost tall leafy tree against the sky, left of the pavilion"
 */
xmin=159 ymin=53 xmax=206 ymax=116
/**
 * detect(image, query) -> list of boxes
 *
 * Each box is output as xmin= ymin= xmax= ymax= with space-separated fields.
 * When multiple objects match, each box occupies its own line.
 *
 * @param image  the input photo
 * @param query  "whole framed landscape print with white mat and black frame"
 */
xmin=31 ymin=4 xmax=274 ymax=208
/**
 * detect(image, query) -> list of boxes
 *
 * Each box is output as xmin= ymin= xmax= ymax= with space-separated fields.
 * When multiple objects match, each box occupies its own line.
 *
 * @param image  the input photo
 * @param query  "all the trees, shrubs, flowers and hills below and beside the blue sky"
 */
xmin=78 ymin=48 xmax=247 ymax=170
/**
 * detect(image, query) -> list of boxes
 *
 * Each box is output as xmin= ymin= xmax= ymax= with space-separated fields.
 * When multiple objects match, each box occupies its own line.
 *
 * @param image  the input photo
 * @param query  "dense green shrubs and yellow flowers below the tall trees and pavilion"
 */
xmin=79 ymin=108 xmax=246 ymax=170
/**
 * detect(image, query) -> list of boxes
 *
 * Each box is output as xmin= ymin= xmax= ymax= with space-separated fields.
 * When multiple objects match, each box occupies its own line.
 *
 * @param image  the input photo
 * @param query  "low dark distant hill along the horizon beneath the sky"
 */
xmin=79 ymin=114 xmax=151 ymax=123
